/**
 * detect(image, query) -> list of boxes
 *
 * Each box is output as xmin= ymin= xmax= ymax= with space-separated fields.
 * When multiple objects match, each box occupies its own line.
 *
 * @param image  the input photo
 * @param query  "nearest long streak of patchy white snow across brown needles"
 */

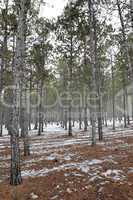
xmin=22 ymin=158 xmax=126 ymax=184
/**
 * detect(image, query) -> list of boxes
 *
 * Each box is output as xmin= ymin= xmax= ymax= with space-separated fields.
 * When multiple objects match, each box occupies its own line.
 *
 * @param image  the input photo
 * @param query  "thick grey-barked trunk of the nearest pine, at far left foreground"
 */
xmin=10 ymin=0 xmax=30 ymax=185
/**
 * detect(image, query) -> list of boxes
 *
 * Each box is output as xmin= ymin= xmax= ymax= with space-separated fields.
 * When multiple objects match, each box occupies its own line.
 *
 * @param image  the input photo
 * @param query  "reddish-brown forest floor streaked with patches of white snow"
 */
xmin=0 ymin=124 xmax=133 ymax=200
